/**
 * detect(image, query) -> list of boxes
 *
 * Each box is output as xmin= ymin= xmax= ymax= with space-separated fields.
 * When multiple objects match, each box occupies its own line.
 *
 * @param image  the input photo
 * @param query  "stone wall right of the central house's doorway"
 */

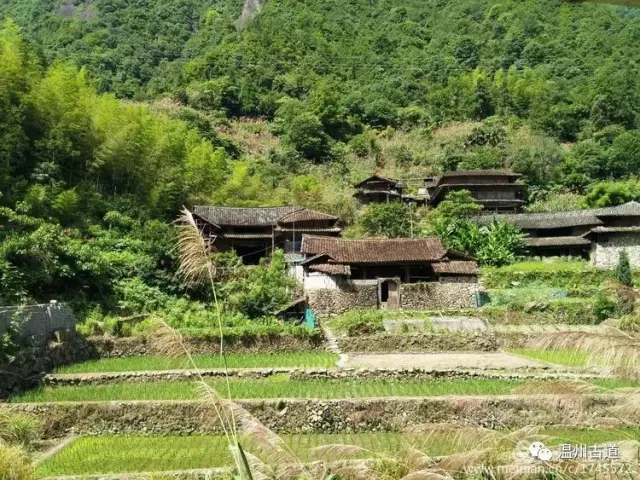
xmin=400 ymin=284 xmax=479 ymax=310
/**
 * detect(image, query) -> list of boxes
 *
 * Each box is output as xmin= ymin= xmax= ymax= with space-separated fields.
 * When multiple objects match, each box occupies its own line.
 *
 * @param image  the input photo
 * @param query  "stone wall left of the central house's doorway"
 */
xmin=307 ymin=282 xmax=378 ymax=316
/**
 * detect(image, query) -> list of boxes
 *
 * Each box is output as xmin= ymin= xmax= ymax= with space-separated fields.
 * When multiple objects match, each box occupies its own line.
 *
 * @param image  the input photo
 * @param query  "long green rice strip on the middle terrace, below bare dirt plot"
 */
xmin=10 ymin=376 xmax=640 ymax=403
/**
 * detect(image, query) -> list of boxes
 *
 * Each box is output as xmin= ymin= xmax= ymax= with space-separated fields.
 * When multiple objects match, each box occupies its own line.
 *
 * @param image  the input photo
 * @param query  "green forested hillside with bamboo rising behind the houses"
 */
xmin=0 ymin=0 xmax=640 ymax=318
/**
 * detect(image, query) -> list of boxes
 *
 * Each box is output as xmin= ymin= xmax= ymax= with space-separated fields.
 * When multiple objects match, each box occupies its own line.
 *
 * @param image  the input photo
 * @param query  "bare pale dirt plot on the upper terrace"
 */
xmin=346 ymin=352 xmax=544 ymax=369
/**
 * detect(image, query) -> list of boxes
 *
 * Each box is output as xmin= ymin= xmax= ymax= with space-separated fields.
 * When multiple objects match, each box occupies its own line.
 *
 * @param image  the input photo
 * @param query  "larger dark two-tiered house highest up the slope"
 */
xmin=425 ymin=170 xmax=525 ymax=213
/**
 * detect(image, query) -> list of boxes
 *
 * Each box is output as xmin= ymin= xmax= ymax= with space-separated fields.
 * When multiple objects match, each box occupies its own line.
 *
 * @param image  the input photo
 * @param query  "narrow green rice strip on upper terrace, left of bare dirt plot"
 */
xmin=55 ymin=351 xmax=338 ymax=373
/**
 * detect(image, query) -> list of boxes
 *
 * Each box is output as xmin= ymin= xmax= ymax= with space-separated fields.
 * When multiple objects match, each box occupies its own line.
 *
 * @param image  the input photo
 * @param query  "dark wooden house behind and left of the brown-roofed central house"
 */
xmin=193 ymin=206 xmax=342 ymax=265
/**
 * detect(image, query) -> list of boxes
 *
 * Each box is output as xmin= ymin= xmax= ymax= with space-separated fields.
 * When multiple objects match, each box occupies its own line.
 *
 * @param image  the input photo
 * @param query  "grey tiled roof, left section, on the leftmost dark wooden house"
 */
xmin=193 ymin=206 xmax=303 ymax=226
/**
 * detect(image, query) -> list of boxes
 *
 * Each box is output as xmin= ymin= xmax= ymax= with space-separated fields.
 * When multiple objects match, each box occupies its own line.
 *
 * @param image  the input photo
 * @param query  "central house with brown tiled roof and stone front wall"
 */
xmin=296 ymin=235 xmax=479 ymax=316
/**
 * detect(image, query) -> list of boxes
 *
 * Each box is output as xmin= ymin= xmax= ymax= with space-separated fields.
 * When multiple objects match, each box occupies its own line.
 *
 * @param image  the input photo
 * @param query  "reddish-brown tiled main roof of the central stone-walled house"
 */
xmin=302 ymin=235 xmax=447 ymax=265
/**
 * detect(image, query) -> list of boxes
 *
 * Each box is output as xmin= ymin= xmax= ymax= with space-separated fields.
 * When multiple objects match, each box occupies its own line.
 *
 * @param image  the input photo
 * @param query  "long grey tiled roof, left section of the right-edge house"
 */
xmin=477 ymin=210 xmax=604 ymax=230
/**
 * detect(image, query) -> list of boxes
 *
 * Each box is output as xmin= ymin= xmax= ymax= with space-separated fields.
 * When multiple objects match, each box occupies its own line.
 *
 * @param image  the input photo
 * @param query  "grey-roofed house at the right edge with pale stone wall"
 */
xmin=478 ymin=202 xmax=640 ymax=268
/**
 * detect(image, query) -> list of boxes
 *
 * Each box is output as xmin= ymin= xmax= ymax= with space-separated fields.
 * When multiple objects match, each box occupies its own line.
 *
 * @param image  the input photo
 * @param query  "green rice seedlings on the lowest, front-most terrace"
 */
xmin=37 ymin=425 xmax=640 ymax=478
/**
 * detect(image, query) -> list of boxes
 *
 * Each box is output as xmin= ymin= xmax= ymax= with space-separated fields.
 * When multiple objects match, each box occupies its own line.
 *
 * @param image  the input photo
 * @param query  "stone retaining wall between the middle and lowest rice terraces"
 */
xmin=5 ymin=395 xmax=620 ymax=438
